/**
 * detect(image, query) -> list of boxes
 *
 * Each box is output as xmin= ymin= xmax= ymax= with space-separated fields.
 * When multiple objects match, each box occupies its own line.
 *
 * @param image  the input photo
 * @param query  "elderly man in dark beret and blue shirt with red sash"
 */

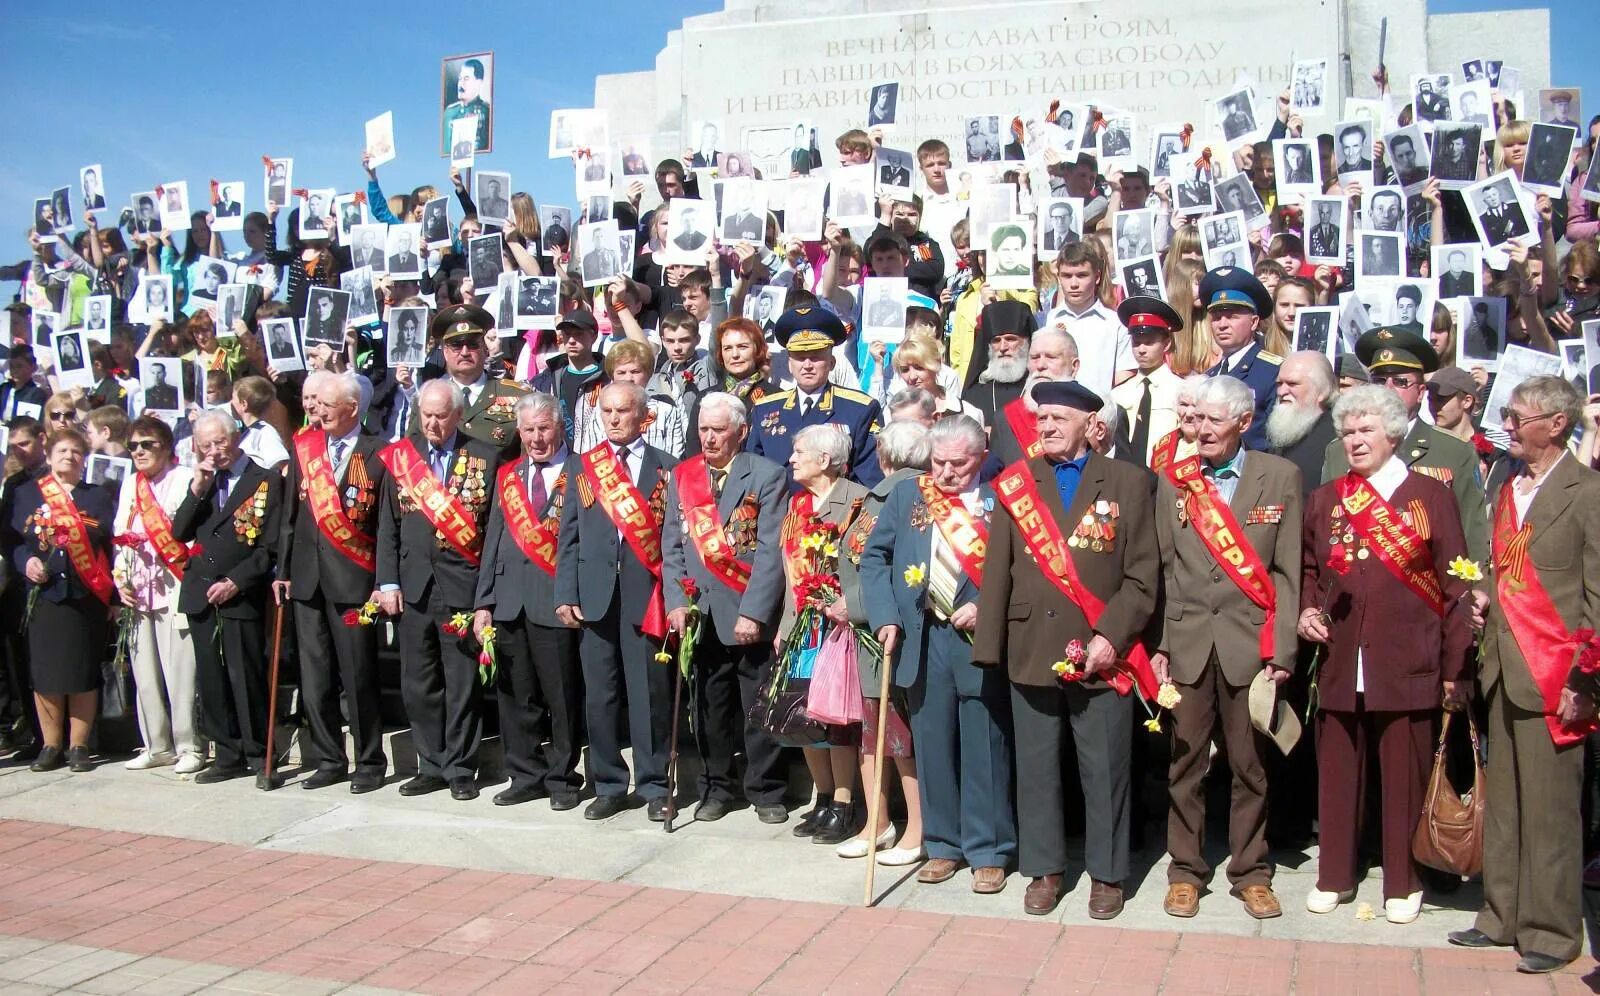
xmin=973 ymin=381 xmax=1160 ymax=919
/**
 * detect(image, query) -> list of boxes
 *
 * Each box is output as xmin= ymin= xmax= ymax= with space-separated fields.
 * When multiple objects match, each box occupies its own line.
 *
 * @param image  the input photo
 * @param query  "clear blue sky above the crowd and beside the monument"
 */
xmin=0 ymin=0 xmax=1600 ymax=291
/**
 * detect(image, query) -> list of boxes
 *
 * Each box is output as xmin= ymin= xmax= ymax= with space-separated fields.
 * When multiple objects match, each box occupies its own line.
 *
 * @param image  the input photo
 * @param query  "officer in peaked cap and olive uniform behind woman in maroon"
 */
xmin=1322 ymin=327 xmax=1490 ymax=566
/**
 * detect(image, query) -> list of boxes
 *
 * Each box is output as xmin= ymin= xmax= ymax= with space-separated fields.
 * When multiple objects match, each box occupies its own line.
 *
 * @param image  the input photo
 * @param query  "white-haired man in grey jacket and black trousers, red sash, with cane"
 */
xmin=662 ymin=392 xmax=789 ymax=823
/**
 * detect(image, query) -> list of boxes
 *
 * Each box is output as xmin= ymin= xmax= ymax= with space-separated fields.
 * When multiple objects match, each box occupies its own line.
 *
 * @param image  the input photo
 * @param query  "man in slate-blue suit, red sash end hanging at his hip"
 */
xmin=555 ymin=384 xmax=677 ymax=823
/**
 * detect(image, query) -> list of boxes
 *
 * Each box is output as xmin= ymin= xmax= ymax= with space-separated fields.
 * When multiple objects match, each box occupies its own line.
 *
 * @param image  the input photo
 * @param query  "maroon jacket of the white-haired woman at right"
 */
xmin=1301 ymin=471 xmax=1472 ymax=713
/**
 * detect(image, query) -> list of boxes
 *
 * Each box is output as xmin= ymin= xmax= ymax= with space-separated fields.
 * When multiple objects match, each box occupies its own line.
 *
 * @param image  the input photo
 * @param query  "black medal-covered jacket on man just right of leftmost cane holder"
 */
xmin=378 ymin=432 xmax=499 ymax=608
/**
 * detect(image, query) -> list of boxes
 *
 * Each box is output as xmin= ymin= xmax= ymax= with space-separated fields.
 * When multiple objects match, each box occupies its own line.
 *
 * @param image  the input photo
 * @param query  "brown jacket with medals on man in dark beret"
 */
xmin=973 ymin=453 xmax=1162 ymax=685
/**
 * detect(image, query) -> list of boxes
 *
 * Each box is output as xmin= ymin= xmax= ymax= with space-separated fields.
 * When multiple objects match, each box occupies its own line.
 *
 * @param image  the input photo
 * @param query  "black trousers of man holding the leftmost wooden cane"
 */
xmin=294 ymin=591 xmax=389 ymax=778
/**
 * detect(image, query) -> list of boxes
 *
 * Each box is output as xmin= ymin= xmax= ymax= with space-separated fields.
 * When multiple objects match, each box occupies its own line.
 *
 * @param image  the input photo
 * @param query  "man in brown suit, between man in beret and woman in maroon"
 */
xmin=1150 ymin=376 xmax=1301 ymax=919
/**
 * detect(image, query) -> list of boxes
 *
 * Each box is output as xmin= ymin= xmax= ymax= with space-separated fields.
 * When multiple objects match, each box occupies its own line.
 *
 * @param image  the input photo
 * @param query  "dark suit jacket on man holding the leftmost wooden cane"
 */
xmin=278 ymin=432 xmax=389 ymax=605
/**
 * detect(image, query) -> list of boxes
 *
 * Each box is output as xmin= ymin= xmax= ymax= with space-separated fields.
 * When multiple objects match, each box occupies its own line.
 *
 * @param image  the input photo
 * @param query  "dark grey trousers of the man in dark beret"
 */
xmin=1011 ymin=684 xmax=1133 ymax=882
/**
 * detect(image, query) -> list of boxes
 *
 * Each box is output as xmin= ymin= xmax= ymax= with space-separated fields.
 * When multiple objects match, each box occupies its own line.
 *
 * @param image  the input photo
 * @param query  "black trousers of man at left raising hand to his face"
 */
xmin=189 ymin=608 xmax=267 ymax=772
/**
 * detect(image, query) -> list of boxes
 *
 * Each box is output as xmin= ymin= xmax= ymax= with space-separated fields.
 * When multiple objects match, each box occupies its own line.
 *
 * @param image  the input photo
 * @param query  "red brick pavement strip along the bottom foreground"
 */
xmin=0 ymin=820 xmax=1592 ymax=996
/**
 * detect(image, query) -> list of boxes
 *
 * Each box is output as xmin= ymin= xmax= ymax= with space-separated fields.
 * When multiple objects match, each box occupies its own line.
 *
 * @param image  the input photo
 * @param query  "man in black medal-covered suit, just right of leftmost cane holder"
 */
xmin=376 ymin=380 xmax=499 ymax=802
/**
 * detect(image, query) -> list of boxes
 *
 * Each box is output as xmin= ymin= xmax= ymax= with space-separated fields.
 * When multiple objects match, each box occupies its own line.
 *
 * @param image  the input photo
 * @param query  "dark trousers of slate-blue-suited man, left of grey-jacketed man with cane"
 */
xmin=578 ymin=584 xmax=672 ymax=799
